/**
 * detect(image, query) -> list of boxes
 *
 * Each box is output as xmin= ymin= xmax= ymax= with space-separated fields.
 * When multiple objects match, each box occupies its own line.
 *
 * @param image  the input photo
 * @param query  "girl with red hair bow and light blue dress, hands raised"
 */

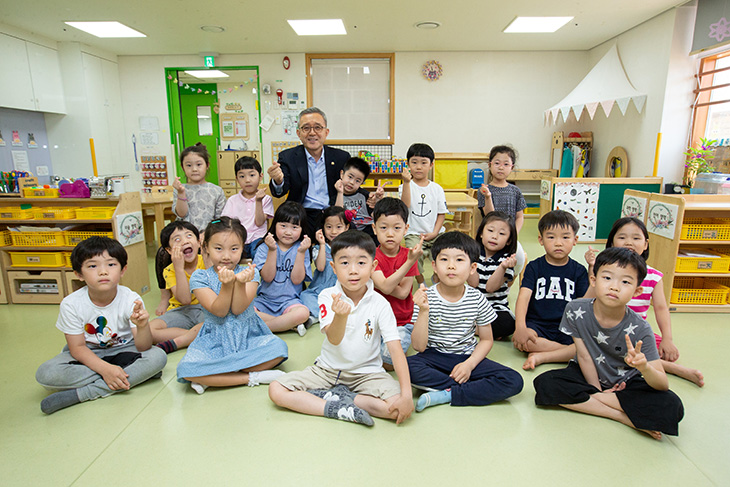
xmin=300 ymin=206 xmax=350 ymax=323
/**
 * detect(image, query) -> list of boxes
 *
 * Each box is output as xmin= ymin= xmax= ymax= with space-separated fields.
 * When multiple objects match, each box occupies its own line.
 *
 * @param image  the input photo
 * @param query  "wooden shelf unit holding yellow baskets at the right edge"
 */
xmin=640 ymin=190 xmax=730 ymax=313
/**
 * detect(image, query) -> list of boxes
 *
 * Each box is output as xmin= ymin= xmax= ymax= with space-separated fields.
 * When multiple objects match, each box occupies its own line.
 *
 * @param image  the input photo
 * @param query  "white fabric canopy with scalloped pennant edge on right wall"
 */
xmin=545 ymin=44 xmax=646 ymax=124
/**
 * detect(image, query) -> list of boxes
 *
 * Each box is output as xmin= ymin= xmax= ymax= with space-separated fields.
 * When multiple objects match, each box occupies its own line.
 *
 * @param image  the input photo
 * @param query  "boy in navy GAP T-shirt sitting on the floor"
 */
xmin=512 ymin=210 xmax=588 ymax=370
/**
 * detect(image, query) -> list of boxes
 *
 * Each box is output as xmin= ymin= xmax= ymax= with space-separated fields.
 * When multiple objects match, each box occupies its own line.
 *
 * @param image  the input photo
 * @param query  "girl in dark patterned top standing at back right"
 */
xmin=477 ymin=145 xmax=527 ymax=275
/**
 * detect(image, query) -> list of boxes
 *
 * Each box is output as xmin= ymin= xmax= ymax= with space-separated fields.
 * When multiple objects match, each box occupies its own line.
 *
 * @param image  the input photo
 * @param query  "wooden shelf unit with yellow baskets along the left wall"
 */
xmin=0 ymin=192 xmax=150 ymax=304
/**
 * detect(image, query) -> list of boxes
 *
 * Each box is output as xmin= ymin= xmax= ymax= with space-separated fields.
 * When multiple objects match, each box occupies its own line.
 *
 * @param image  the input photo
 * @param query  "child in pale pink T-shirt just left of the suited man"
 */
xmin=221 ymin=156 xmax=274 ymax=258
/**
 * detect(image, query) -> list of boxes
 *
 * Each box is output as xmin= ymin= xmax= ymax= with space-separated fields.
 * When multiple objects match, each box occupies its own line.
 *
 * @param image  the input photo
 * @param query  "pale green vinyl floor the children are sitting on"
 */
xmin=0 ymin=220 xmax=730 ymax=487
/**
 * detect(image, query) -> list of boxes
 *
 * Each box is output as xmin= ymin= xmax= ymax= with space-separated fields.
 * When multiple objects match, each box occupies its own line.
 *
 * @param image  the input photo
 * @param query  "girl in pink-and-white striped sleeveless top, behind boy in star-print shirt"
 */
xmin=585 ymin=217 xmax=705 ymax=387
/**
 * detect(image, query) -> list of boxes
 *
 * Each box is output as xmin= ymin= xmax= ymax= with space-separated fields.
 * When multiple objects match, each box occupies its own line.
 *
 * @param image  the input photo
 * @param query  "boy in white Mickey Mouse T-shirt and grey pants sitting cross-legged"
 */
xmin=36 ymin=237 xmax=167 ymax=414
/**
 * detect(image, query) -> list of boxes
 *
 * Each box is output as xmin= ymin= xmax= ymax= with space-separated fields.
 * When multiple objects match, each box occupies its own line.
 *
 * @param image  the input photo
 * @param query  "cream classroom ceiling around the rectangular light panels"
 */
xmin=0 ymin=0 xmax=686 ymax=55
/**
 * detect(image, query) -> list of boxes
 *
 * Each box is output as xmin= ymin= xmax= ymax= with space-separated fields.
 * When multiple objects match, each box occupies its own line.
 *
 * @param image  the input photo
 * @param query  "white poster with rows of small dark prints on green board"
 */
xmin=553 ymin=183 xmax=600 ymax=242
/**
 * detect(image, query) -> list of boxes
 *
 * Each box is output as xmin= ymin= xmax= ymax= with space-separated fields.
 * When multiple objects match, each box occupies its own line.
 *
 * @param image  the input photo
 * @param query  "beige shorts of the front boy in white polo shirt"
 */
xmin=276 ymin=364 xmax=400 ymax=400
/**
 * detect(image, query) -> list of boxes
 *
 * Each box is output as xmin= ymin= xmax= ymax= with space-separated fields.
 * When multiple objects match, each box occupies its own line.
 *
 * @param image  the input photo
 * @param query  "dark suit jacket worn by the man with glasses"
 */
xmin=269 ymin=145 xmax=350 ymax=206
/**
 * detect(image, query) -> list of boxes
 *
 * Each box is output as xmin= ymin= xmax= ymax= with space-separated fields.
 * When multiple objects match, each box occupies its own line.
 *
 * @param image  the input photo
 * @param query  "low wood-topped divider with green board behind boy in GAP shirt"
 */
xmin=540 ymin=177 xmax=663 ymax=243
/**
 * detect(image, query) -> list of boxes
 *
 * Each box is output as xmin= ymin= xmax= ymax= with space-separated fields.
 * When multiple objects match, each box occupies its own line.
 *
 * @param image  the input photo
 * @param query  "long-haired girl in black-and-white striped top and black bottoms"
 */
xmin=468 ymin=211 xmax=517 ymax=339
